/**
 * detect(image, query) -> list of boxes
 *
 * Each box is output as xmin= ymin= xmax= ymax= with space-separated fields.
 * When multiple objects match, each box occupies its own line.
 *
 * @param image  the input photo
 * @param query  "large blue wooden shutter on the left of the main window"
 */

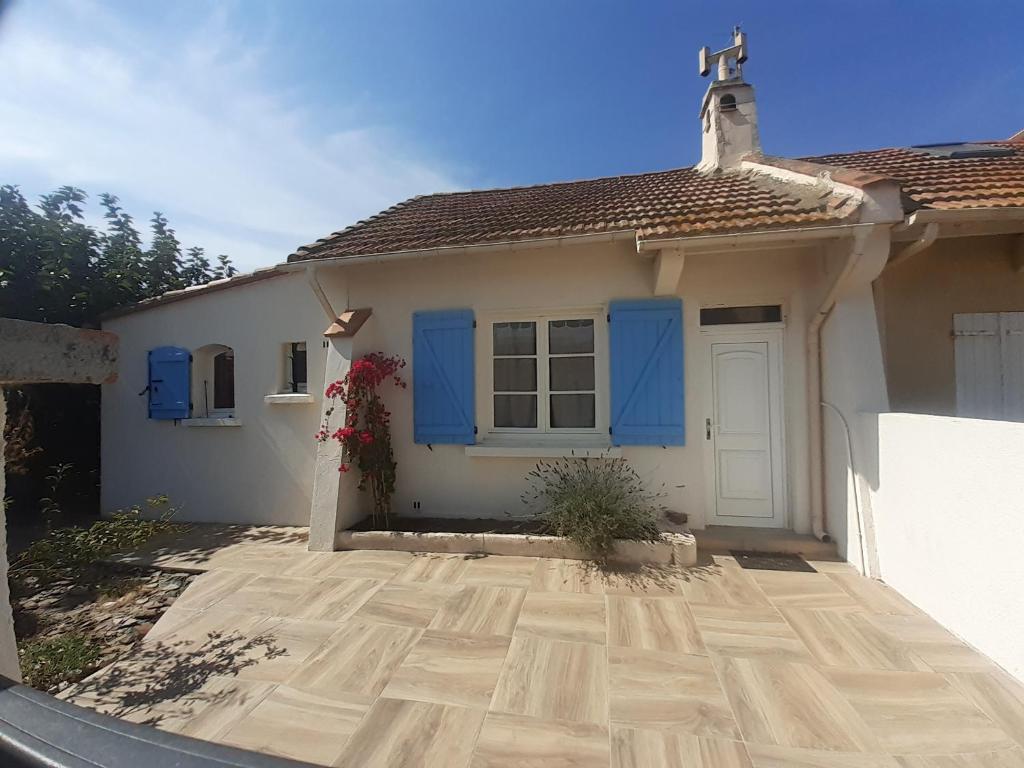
xmin=413 ymin=309 xmax=476 ymax=445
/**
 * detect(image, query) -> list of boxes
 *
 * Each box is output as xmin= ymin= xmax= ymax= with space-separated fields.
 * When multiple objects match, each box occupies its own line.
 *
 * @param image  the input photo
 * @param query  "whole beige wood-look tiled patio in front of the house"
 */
xmin=69 ymin=542 xmax=1024 ymax=768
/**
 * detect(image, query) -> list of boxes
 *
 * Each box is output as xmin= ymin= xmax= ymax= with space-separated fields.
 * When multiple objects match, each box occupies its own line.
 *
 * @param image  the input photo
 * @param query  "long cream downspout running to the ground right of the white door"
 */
xmin=807 ymin=229 xmax=870 ymax=542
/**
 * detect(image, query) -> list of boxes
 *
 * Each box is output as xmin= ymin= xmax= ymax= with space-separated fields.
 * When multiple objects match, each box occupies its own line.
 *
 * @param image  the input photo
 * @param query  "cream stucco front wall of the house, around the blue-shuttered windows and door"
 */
xmin=103 ymin=243 xmax=824 ymax=530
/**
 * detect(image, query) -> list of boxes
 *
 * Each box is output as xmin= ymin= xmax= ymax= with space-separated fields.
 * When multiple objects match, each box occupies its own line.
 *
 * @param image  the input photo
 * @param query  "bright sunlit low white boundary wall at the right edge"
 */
xmin=864 ymin=414 xmax=1024 ymax=680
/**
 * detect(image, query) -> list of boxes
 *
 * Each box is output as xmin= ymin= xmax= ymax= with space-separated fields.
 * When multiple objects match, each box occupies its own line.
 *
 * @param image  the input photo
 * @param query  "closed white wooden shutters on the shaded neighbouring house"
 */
xmin=953 ymin=312 xmax=1024 ymax=421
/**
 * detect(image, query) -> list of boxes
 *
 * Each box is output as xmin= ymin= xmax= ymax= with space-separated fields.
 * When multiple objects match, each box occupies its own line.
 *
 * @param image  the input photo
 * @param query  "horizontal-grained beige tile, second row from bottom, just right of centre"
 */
xmin=608 ymin=647 xmax=739 ymax=738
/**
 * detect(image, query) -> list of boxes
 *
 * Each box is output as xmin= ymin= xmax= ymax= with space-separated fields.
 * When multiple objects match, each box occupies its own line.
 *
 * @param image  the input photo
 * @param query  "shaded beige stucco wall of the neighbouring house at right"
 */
xmin=876 ymin=237 xmax=1024 ymax=416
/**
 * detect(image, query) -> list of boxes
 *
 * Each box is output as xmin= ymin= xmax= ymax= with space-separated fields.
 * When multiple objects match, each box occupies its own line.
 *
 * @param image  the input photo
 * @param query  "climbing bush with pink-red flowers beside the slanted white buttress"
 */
xmin=315 ymin=352 xmax=408 ymax=527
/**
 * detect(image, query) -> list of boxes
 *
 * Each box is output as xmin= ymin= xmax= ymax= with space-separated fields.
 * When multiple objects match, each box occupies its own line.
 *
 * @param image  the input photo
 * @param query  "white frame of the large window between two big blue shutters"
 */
xmin=476 ymin=306 xmax=610 ymax=444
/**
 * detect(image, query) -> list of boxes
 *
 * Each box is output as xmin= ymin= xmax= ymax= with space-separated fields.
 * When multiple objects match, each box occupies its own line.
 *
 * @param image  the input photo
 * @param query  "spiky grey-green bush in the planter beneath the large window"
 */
xmin=523 ymin=457 xmax=664 ymax=559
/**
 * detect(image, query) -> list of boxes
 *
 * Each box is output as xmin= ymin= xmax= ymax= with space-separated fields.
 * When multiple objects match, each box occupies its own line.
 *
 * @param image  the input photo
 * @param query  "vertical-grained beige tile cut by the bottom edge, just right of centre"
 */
xmin=611 ymin=727 xmax=753 ymax=768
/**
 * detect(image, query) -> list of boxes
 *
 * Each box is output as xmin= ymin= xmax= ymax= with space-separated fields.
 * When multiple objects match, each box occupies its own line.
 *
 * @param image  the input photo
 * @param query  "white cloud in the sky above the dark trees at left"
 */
xmin=0 ymin=2 xmax=459 ymax=269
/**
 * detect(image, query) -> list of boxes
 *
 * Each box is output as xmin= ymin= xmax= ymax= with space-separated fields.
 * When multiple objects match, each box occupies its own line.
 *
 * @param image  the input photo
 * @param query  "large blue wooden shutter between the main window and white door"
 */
xmin=608 ymin=299 xmax=686 ymax=445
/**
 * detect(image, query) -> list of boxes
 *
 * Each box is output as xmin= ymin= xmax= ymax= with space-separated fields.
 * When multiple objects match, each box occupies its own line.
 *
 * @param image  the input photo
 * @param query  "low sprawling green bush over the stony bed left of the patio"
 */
xmin=10 ymin=496 xmax=184 ymax=581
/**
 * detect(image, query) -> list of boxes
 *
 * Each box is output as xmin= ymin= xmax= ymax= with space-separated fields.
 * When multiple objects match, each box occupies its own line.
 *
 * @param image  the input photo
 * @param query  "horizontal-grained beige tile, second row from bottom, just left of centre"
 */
xmin=381 ymin=630 xmax=511 ymax=710
